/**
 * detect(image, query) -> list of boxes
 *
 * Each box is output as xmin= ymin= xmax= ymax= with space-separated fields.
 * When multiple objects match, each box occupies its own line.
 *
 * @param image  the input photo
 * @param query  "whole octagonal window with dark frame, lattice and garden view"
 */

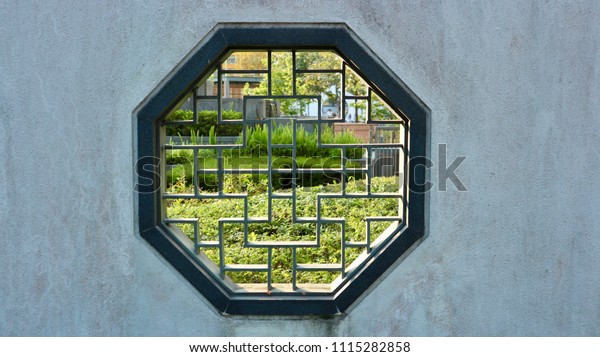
xmin=136 ymin=24 xmax=427 ymax=314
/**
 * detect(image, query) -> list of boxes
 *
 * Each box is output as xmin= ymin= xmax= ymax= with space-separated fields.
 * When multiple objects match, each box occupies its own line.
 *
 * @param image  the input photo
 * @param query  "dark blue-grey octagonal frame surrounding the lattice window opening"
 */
xmin=134 ymin=23 xmax=429 ymax=315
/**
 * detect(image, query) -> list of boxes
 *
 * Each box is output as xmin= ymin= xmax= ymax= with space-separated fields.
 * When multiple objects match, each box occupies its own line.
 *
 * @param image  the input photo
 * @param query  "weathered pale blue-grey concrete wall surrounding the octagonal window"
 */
xmin=0 ymin=0 xmax=600 ymax=335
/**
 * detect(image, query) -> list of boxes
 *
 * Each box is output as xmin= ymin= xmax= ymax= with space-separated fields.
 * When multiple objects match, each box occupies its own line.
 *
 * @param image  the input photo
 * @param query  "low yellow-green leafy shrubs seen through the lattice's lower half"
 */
xmin=167 ymin=177 xmax=399 ymax=283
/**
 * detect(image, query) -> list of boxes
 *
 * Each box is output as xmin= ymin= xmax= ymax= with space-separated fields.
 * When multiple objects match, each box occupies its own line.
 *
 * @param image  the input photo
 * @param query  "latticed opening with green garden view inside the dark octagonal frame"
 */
xmin=160 ymin=49 xmax=408 ymax=294
